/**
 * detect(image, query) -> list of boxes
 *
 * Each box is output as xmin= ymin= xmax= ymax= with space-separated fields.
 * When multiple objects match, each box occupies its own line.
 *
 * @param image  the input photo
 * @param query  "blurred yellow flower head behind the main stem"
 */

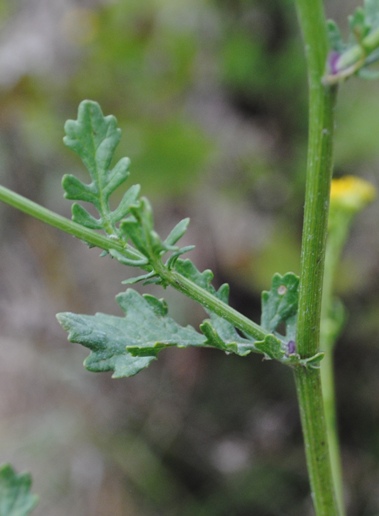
xmin=330 ymin=176 xmax=376 ymax=213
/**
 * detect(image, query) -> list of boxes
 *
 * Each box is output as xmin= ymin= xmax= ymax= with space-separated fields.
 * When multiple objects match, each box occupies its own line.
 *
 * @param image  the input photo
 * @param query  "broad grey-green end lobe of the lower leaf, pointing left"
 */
xmin=57 ymin=289 xmax=204 ymax=378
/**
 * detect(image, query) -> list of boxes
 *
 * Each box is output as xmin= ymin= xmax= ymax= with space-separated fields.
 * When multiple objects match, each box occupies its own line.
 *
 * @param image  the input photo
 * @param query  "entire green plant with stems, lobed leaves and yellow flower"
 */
xmin=0 ymin=0 xmax=379 ymax=516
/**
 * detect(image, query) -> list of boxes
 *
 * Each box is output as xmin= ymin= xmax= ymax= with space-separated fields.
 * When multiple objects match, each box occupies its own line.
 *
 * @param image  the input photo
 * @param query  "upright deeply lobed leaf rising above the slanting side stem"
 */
xmin=62 ymin=100 xmax=193 ymax=274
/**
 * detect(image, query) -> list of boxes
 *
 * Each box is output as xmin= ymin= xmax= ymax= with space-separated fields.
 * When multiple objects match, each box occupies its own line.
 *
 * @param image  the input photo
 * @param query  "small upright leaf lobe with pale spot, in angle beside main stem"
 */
xmin=261 ymin=272 xmax=299 ymax=340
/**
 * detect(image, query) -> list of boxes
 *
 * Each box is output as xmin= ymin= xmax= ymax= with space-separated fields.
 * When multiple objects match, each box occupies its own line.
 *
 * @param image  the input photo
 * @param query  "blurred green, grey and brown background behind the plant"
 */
xmin=0 ymin=0 xmax=379 ymax=516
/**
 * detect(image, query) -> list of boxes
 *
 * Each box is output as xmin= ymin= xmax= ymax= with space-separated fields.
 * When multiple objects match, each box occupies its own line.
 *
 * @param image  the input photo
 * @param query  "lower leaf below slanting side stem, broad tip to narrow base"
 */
xmin=57 ymin=289 xmax=290 ymax=378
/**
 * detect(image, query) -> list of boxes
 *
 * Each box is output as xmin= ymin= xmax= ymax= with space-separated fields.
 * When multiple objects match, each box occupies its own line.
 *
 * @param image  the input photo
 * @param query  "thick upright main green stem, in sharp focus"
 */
xmin=295 ymin=0 xmax=338 ymax=516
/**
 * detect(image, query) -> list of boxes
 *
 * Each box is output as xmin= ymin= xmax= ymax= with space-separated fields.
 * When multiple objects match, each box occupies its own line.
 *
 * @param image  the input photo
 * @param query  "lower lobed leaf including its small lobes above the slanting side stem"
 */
xmin=57 ymin=272 xmax=304 ymax=378
